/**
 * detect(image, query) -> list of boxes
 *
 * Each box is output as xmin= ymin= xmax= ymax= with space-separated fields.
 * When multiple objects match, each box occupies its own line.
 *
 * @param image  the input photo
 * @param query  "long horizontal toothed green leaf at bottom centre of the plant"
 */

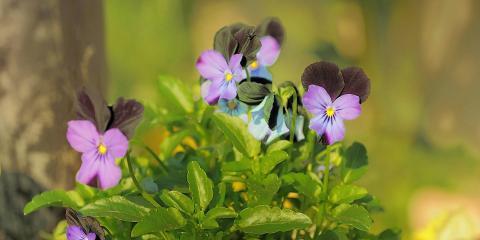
xmin=235 ymin=205 xmax=312 ymax=234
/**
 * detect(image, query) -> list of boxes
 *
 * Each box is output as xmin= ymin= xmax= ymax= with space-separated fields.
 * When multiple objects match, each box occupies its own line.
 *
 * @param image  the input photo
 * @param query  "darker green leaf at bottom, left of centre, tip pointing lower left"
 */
xmin=132 ymin=208 xmax=187 ymax=237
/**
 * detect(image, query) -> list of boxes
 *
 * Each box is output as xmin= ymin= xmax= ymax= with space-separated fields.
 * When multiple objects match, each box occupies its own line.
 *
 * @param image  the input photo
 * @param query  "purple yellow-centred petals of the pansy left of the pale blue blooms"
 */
xmin=196 ymin=50 xmax=245 ymax=105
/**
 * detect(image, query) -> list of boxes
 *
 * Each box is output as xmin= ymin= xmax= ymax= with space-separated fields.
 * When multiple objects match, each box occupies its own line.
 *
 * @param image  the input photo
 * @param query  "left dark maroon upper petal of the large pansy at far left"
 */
xmin=75 ymin=88 xmax=111 ymax=132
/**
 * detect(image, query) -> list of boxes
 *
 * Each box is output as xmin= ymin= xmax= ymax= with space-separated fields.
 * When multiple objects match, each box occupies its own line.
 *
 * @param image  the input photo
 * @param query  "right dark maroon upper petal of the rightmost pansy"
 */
xmin=342 ymin=67 xmax=370 ymax=103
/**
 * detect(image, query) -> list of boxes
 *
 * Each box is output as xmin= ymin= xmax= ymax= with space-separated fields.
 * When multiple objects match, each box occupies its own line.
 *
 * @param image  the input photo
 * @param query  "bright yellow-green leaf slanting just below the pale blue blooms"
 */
xmin=213 ymin=113 xmax=260 ymax=157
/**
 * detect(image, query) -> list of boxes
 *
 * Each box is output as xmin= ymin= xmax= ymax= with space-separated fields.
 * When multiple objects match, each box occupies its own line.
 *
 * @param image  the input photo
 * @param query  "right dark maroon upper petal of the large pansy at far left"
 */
xmin=109 ymin=98 xmax=143 ymax=139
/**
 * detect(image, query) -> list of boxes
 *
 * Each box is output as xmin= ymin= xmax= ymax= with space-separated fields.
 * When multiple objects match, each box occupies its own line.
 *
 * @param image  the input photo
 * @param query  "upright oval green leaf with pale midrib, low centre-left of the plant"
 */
xmin=187 ymin=161 xmax=213 ymax=210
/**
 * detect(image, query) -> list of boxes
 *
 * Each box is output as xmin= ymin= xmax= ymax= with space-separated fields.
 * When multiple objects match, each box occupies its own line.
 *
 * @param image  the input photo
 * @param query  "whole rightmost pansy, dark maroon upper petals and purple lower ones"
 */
xmin=302 ymin=62 xmax=370 ymax=144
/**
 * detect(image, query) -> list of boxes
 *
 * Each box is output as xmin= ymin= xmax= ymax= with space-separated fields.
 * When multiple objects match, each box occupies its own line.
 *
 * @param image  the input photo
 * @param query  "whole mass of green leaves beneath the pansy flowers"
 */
xmin=24 ymin=77 xmax=400 ymax=240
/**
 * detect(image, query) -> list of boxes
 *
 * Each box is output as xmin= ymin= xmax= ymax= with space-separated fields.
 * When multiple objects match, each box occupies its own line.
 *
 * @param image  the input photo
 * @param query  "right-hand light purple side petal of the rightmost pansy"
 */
xmin=333 ymin=94 xmax=362 ymax=120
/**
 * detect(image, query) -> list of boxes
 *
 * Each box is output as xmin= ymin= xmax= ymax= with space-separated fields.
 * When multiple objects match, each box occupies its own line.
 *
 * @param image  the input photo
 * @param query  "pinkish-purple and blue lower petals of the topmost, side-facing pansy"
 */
xmin=248 ymin=36 xmax=280 ymax=81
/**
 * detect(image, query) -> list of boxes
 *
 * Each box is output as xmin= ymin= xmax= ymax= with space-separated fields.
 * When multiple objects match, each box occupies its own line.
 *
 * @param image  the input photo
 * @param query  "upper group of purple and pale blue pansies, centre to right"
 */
xmin=196 ymin=19 xmax=370 ymax=144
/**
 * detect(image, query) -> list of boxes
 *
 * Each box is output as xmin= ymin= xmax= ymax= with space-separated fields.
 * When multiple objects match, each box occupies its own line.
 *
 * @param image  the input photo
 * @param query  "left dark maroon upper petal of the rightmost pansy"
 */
xmin=302 ymin=61 xmax=345 ymax=101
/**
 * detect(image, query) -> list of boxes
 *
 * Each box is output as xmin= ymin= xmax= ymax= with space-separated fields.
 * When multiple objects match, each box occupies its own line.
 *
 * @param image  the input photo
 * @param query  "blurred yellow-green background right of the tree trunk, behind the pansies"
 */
xmin=105 ymin=0 xmax=480 ymax=238
